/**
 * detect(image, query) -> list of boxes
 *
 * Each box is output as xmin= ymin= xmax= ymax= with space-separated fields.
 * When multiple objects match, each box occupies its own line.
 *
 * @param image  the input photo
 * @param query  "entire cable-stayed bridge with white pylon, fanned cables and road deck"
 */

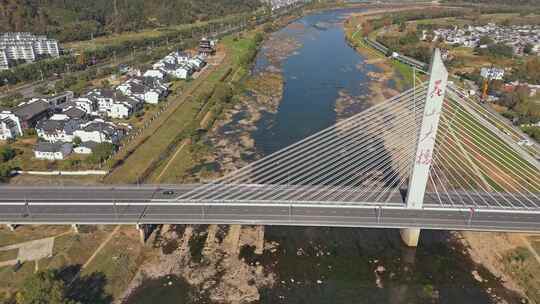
xmin=0 ymin=51 xmax=540 ymax=245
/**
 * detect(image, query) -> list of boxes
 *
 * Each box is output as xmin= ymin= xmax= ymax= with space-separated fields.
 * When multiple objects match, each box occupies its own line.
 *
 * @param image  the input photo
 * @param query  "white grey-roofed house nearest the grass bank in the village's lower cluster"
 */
xmin=73 ymin=119 xmax=124 ymax=144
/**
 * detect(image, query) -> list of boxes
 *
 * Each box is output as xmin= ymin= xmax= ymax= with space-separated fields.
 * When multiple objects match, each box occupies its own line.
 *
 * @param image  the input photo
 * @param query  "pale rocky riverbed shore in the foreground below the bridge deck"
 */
xmin=121 ymin=225 xmax=275 ymax=304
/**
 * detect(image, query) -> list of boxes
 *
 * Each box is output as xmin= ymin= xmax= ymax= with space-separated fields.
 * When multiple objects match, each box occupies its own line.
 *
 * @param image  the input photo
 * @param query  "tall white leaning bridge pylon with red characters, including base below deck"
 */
xmin=401 ymin=49 xmax=448 ymax=247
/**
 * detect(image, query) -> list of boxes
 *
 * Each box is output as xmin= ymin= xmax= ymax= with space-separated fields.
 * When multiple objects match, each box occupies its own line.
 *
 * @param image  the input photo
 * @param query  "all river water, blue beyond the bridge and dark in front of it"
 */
xmin=125 ymin=10 xmax=518 ymax=304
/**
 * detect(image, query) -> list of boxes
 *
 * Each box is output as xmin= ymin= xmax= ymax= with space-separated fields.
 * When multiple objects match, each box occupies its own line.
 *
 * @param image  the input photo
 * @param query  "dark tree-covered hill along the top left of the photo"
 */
xmin=0 ymin=0 xmax=261 ymax=41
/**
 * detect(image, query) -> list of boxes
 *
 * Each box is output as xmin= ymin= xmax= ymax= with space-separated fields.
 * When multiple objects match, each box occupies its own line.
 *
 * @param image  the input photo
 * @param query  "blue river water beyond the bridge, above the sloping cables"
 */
xmin=253 ymin=10 xmax=377 ymax=155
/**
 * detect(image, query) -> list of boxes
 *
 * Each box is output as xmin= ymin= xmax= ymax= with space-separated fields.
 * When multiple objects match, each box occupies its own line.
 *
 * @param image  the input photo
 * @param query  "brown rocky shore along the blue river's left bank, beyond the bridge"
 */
xmin=202 ymin=23 xmax=302 ymax=178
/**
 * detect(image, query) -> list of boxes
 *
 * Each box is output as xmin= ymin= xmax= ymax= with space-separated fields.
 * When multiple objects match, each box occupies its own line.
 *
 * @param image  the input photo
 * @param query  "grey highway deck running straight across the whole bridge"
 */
xmin=0 ymin=185 xmax=540 ymax=232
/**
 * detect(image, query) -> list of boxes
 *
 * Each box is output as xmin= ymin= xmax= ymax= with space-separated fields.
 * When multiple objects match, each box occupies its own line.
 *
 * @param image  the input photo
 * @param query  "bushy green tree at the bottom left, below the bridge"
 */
xmin=15 ymin=270 xmax=76 ymax=304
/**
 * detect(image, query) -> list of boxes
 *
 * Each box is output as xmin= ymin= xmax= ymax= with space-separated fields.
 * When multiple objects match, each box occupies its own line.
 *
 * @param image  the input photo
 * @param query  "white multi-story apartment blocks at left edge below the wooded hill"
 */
xmin=0 ymin=33 xmax=60 ymax=70
